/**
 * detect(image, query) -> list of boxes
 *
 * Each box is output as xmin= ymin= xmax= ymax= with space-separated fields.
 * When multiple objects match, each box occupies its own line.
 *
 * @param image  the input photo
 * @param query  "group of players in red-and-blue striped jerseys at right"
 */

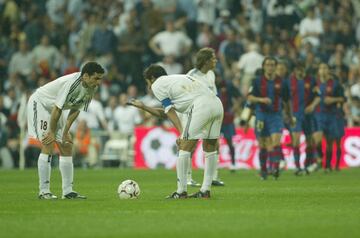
xmin=245 ymin=57 xmax=346 ymax=180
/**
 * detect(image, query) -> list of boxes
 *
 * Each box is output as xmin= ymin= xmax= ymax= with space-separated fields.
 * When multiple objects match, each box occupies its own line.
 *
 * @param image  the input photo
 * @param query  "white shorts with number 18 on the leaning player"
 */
xmin=27 ymin=94 xmax=67 ymax=142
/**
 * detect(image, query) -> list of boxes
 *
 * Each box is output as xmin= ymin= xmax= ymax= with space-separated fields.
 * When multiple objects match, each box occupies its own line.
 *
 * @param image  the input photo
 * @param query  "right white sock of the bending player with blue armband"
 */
xmin=200 ymin=151 xmax=218 ymax=192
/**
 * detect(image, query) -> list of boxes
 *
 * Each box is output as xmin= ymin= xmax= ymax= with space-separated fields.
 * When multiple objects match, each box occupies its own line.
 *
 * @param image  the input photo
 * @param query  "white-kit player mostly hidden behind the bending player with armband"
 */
xmin=186 ymin=47 xmax=225 ymax=187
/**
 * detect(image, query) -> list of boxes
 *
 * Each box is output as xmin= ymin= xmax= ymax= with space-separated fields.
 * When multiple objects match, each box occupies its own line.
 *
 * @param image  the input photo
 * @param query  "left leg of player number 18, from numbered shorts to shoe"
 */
xmin=27 ymin=96 xmax=57 ymax=199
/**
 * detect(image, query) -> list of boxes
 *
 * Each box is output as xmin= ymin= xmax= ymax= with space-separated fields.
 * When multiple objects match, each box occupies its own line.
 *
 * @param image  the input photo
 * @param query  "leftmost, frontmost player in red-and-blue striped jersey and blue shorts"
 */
xmin=248 ymin=57 xmax=295 ymax=180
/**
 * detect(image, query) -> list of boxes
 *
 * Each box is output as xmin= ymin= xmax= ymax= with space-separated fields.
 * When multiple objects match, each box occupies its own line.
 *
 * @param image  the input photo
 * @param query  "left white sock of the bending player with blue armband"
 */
xmin=176 ymin=150 xmax=191 ymax=193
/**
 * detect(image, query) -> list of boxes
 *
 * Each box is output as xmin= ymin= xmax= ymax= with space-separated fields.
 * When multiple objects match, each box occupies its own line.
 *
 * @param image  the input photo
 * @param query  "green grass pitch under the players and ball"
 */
xmin=0 ymin=169 xmax=360 ymax=238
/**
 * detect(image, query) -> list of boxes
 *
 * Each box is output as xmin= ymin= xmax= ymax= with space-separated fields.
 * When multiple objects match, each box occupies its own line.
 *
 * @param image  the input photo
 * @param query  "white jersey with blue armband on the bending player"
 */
xmin=151 ymin=74 xmax=216 ymax=113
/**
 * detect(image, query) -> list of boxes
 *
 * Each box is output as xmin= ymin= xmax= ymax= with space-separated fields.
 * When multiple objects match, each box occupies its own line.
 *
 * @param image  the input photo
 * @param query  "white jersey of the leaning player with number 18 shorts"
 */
xmin=34 ymin=72 xmax=97 ymax=111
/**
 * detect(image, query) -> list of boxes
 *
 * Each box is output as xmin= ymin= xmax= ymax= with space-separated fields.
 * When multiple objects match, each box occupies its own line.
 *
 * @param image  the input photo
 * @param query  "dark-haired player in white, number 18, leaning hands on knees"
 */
xmin=27 ymin=62 xmax=105 ymax=199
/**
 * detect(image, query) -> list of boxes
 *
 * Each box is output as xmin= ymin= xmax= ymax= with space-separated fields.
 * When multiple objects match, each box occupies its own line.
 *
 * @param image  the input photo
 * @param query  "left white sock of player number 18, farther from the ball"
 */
xmin=38 ymin=153 xmax=51 ymax=193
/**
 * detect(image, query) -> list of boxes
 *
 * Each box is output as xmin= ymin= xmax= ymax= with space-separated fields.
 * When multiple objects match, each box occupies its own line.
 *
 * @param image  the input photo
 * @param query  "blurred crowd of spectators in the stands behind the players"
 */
xmin=0 ymin=0 xmax=360 ymax=167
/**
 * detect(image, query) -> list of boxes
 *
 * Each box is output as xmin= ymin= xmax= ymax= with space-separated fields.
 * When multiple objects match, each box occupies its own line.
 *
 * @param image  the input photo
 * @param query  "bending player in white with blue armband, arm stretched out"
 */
xmin=133 ymin=65 xmax=223 ymax=199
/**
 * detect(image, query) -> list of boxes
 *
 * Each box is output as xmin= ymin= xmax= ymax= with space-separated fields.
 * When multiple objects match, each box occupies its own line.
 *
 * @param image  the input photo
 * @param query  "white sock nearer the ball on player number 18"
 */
xmin=59 ymin=156 xmax=74 ymax=195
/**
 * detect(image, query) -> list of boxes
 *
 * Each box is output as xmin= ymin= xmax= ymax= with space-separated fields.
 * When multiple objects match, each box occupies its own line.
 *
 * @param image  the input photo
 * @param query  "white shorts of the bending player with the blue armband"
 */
xmin=181 ymin=96 xmax=224 ymax=140
